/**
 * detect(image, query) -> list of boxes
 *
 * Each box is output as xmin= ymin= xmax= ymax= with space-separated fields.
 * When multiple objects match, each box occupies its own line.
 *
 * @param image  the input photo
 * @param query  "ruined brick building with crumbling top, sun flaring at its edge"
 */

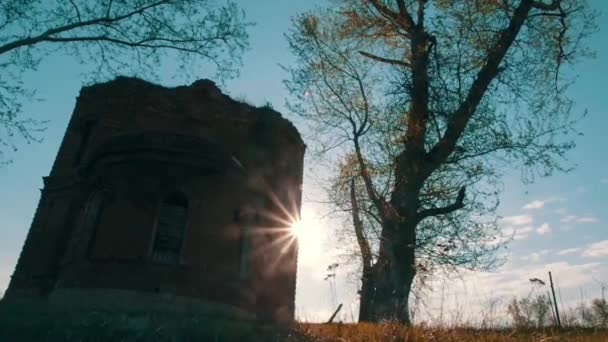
xmin=4 ymin=77 xmax=305 ymax=320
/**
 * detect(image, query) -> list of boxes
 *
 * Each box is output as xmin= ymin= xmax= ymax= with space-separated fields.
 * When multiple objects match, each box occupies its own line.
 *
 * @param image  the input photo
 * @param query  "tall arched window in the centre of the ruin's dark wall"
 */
xmin=152 ymin=192 xmax=188 ymax=264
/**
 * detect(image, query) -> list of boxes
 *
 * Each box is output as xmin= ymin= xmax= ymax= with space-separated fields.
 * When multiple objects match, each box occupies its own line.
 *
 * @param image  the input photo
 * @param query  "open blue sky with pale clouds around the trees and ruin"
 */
xmin=0 ymin=0 xmax=608 ymax=320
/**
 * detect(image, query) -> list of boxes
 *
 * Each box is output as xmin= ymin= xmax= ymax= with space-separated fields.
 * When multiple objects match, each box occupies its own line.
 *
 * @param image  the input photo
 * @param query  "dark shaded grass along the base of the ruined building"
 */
xmin=0 ymin=312 xmax=290 ymax=342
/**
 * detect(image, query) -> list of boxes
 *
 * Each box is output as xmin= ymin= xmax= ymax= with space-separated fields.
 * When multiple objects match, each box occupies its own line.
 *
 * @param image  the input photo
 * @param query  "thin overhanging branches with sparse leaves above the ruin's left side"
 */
xmin=0 ymin=0 xmax=249 ymax=163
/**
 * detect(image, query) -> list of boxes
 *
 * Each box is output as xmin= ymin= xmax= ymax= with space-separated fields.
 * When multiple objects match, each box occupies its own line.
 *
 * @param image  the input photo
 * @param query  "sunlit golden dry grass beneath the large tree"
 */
xmin=292 ymin=323 xmax=608 ymax=342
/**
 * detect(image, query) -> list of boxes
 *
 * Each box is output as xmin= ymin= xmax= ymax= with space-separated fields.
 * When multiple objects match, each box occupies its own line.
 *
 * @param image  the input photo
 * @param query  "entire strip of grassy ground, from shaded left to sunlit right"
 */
xmin=0 ymin=312 xmax=608 ymax=342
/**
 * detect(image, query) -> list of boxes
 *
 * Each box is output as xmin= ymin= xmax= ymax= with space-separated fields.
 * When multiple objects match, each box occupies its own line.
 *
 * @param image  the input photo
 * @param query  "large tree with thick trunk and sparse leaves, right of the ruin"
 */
xmin=286 ymin=0 xmax=594 ymax=323
